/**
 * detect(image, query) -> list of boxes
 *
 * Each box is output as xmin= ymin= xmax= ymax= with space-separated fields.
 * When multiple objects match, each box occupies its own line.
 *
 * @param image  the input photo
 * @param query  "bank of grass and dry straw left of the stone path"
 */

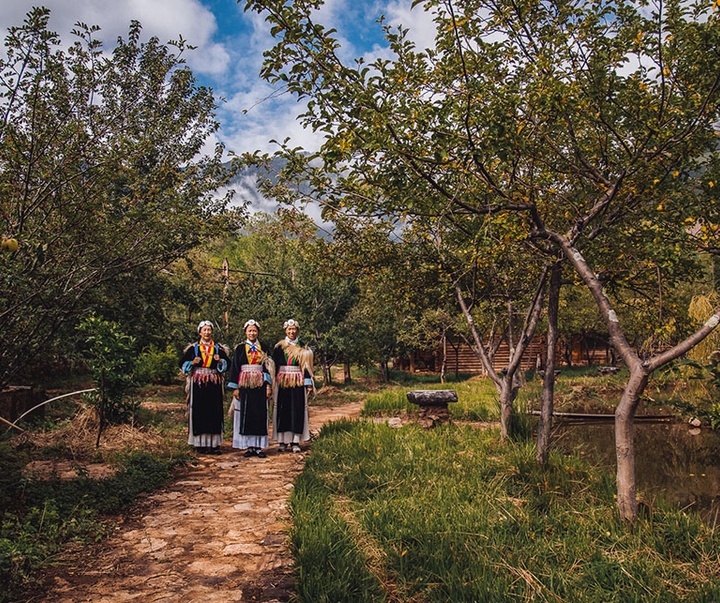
xmin=0 ymin=387 xmax=190 ymax=603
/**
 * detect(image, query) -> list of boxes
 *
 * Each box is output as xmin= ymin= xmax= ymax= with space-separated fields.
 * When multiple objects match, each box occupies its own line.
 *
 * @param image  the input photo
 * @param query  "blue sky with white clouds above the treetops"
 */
xmin=0 ymin=0 xmax=432 ymax=153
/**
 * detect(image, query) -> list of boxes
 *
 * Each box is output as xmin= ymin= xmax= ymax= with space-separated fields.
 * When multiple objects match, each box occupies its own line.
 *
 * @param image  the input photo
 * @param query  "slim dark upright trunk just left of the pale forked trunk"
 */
xmin=535 ymin=262 xmax=562 ymax=465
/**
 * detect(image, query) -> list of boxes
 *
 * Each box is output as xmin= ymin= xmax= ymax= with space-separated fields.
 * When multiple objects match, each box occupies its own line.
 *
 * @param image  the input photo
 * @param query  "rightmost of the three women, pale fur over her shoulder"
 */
xmin=273 ymin=318 xmax=314 ymax=452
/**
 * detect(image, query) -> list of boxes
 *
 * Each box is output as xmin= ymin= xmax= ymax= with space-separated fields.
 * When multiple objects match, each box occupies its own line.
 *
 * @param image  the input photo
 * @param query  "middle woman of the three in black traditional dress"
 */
xmin=228 ymin=319 xmax=274 ymax=458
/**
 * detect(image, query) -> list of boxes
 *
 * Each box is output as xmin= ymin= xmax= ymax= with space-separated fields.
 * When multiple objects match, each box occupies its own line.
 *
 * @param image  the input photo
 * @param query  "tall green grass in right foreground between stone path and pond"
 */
xmin=291 ymin=421 xmax=720 ymax=603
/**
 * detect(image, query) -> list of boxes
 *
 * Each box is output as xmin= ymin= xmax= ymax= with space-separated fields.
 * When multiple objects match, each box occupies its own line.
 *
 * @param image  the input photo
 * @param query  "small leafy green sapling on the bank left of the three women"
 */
xmin=78 ymin=316 xmax=139 ymax=442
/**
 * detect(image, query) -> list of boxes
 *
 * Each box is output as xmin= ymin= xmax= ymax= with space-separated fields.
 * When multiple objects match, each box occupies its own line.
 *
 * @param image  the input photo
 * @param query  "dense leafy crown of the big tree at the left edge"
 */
xmin=0 ymin=8 xmax=238 ymax=384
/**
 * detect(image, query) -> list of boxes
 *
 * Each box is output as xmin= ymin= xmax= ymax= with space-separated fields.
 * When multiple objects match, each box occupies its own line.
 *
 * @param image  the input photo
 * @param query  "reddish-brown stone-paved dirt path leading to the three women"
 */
xmin=43 ymin=403 xmax=361 ymax=603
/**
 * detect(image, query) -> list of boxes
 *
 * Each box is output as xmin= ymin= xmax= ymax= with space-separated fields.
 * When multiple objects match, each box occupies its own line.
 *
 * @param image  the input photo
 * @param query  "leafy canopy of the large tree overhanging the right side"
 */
xmin=247 ymin=0 xmax=720 ymax=308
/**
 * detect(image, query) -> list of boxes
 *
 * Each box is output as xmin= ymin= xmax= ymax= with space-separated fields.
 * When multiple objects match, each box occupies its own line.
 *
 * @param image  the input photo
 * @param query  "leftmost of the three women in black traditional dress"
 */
xmin=180 ymin=320 xmax=228 ymax=454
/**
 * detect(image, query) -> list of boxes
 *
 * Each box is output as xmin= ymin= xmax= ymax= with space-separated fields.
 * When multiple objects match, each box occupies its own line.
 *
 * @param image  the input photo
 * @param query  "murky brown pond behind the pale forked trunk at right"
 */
xmin=553 ymin=422 xmax=720 ymax=525
